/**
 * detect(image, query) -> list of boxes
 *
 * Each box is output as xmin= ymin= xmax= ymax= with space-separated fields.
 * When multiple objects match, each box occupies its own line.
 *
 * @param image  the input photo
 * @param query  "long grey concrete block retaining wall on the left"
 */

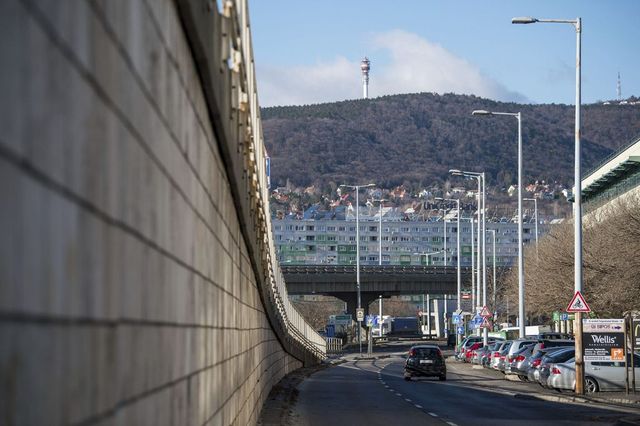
xmin=0 ymin=0 xmax=318 ymax=425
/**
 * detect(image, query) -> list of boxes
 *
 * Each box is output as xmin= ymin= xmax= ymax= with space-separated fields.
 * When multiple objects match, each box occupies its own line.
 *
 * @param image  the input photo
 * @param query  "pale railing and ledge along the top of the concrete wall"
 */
xmin=178 ymin=0 xmax=326 ymax=359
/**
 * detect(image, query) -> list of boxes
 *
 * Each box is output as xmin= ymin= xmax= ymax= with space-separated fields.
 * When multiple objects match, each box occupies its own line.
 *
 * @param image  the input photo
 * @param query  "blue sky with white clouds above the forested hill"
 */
xmin=249 ymin=0 xmax=640 ymax=107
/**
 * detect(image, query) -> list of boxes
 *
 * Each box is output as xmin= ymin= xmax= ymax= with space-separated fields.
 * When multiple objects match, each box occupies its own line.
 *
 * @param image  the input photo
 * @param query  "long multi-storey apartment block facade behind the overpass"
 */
xmin=272 ymin=208 xmax=546 ymax=266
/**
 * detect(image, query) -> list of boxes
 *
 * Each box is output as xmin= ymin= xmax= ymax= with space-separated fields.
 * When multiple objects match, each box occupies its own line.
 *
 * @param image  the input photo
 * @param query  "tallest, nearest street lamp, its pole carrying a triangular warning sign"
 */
xmin=511 ymin=17 xmax=584 ymax=395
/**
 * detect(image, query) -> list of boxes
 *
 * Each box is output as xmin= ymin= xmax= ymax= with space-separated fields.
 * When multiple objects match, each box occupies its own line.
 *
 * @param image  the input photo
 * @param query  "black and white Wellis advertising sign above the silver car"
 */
xmin=582 ymin=319 xmax=624 ymax=361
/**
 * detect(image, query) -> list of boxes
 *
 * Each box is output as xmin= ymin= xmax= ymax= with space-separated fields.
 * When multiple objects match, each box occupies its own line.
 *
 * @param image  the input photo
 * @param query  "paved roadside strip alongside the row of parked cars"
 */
xmin=447 ymin=357 xmax=640 ymax=412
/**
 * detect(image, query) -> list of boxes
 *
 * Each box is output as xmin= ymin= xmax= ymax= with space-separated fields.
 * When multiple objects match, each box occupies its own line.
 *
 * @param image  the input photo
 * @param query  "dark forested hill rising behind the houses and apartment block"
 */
xmin=262 ymin=93 xmax=640 ymax=188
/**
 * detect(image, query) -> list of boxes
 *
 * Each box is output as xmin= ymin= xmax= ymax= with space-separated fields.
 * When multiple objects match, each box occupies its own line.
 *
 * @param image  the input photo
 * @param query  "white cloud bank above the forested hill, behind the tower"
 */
xmin=258 ymin=30 xmax=527 ymax=106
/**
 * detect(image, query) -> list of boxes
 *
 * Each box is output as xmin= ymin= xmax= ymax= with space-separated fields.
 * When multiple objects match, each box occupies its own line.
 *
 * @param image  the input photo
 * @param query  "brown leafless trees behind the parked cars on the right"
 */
xmin=501 ymin=192 xmax=640 ymax=316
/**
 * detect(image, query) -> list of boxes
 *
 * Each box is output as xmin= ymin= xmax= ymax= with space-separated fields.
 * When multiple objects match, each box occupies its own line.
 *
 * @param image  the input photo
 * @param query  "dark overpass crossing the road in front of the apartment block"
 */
xmin=282 ymin=265 xmax=471 ymax=318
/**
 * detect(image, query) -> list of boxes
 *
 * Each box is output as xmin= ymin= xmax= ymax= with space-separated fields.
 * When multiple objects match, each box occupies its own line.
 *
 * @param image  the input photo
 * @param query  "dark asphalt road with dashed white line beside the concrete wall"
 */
xmin=290 ymin=344 xmax=640 ymax=426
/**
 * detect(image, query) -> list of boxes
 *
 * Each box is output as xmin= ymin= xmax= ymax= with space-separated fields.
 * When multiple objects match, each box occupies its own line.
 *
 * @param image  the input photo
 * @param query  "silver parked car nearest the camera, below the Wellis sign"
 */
xmin=547 ymin=354 xmax=640 ymax=393
